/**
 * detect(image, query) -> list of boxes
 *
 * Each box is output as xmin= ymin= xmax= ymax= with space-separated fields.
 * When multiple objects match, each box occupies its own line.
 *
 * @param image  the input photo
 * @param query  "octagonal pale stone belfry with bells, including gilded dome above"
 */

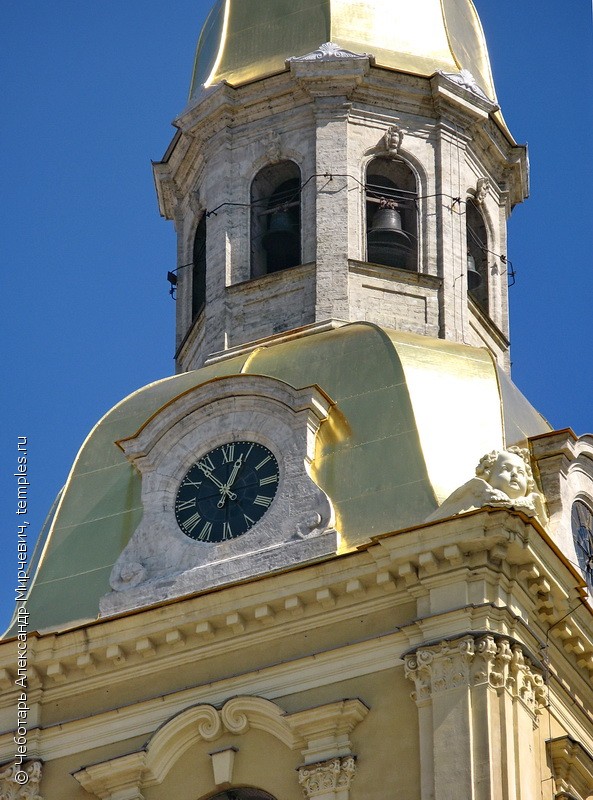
xmin=154 ymin=0 xmax=528 ymax=371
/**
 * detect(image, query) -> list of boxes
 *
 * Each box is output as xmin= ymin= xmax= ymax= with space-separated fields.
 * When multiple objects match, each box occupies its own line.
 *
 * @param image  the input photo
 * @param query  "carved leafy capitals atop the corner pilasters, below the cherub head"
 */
xmin=404 ymin=635 xmax=547 ymax=714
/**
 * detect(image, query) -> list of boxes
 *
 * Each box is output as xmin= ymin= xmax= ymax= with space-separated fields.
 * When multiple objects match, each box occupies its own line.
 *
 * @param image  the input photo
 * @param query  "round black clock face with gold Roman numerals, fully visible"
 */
xmin=175 ymin=442 xmax=279 ymax=542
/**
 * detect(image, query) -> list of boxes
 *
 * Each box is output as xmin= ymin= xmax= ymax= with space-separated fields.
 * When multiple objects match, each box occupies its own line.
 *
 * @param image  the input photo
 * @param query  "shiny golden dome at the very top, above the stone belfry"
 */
xmin=190 ymin=0 xmax=496 ymax=101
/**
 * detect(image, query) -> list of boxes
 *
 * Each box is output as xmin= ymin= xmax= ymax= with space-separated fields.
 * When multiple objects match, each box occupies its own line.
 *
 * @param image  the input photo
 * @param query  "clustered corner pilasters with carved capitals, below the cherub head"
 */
xmin=405 ymin=635 xmax=545 ymax=800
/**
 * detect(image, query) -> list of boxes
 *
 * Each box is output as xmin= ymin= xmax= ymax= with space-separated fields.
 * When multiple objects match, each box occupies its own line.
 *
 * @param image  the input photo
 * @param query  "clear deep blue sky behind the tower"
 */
xmin=0 ymin=0 xmax=593 ymax=627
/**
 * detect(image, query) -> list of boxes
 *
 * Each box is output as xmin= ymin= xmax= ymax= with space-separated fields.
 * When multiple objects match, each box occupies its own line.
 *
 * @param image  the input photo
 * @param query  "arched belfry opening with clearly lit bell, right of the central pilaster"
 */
xmin=366 ymin=158 xmax=418 ymax=270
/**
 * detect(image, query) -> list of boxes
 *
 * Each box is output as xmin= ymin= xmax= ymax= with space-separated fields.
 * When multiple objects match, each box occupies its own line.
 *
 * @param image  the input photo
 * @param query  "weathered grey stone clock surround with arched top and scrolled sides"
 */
xmin=101 ymin=375 xmax=338 ymax=615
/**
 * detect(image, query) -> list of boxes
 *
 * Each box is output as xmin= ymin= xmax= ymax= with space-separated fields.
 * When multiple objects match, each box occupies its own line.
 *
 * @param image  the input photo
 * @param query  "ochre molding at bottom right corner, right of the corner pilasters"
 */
xmin=546 ymin=736 xmax=593 ymax=800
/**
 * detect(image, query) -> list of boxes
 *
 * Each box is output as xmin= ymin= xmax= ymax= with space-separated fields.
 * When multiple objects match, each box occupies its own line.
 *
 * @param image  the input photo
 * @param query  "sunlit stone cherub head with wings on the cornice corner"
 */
xmin=427 ymin=447 xmax=547 ymax=524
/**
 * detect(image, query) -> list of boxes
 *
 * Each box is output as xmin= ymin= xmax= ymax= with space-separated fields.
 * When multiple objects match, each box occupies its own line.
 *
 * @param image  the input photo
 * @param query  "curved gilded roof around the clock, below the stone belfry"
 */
xmin=5 ymin=323 xmax=549 ymax=629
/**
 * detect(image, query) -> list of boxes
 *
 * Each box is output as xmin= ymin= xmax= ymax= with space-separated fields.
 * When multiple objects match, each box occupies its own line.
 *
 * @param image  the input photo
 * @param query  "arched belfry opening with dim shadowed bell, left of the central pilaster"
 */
xmin=251 ymin=161 xmax=301 ymax=278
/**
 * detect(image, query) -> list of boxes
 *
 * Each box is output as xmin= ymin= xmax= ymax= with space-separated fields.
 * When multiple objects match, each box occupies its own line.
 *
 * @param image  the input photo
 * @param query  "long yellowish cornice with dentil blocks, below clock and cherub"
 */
xmin=0 ymin=510 xmax=593 ymax=701
